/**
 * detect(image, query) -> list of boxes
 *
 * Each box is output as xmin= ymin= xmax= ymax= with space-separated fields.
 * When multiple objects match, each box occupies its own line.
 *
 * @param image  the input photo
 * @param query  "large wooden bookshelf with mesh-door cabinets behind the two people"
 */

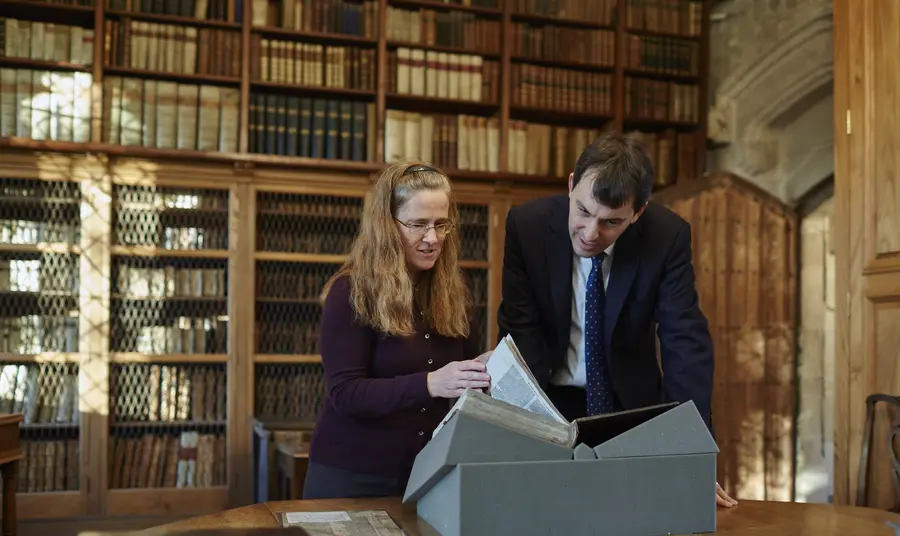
xmin=0 ymin=0 xmax=709 ymax=518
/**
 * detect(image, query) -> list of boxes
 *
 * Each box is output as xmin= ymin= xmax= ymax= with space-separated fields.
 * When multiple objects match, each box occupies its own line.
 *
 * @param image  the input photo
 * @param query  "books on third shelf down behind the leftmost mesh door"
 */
xmin=0 ymin=318 xmax=78 ymax=355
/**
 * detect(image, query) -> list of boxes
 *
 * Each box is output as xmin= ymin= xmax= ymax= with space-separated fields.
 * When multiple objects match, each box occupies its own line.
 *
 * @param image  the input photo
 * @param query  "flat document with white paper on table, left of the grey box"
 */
xmin=281 ymin=510 xmax=406 ymax=536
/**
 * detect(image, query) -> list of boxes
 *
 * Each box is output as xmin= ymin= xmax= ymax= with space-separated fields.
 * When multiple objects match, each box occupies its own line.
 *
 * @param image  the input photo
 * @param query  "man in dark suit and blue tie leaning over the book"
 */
xmin=497 ymin=133 xmax=737 ymax=506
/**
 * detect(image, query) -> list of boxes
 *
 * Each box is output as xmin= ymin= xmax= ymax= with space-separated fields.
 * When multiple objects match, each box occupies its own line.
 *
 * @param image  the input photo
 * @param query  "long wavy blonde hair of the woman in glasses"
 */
xmin=321 ymin=162 xmax=472 ymax=337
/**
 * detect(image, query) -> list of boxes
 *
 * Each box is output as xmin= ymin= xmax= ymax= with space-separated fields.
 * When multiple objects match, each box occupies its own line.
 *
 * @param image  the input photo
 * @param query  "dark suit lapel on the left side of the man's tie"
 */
xmin=544 ymin=198 xmax=573 ymax=351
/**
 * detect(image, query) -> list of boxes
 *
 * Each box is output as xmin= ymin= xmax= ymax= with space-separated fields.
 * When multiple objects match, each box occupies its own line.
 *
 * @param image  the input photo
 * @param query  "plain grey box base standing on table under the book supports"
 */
xmin=416 ymin=454 xmax=716 ymax=536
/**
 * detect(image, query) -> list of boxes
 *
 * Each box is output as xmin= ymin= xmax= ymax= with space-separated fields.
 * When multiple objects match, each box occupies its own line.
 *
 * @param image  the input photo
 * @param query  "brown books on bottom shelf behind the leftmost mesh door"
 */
xmin=16 ymin=439 xmax=81 ymax=493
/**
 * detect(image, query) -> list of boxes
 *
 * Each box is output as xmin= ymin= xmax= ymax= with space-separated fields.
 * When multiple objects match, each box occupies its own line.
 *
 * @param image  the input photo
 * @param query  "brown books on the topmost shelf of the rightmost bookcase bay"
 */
xmin=624 ymin=0 xmax=703 ymax=37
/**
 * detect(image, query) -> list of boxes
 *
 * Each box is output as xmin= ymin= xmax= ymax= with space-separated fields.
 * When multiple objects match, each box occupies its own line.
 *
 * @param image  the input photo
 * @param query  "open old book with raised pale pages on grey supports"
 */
xmin=432 ymin=335 xmax=672 ymax=448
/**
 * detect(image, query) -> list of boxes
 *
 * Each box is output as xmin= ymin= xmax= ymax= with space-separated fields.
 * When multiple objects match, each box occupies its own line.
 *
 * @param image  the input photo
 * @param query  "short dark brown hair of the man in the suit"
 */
xmin=572 ymin=131 xmax=653 ymax=211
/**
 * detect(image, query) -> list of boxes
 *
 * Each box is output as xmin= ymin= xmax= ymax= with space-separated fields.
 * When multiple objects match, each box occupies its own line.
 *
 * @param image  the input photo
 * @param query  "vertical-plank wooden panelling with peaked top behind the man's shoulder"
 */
xmin=656 ymin=174 xmax=797 ymax=500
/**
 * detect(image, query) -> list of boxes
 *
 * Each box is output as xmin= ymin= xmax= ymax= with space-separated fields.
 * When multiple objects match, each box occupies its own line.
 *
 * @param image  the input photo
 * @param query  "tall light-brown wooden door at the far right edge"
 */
xmin=834 ymin=0 xmax=900 ymax=508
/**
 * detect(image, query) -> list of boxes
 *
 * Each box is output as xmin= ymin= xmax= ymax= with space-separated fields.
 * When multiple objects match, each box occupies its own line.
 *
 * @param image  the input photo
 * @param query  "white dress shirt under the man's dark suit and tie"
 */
xmin=550 ymin=244 xmax=615 ymax=387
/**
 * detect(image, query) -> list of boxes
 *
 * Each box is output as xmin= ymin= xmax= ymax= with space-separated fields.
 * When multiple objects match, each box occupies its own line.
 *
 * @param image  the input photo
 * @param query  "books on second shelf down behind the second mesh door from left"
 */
xmin=117 ymin=264 xmax=228 ymax=299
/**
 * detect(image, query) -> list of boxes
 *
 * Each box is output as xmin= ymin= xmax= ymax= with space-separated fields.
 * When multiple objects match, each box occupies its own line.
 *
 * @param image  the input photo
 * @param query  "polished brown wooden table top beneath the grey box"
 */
xmin=141 ymin=499 xmax=900 ymax=536
